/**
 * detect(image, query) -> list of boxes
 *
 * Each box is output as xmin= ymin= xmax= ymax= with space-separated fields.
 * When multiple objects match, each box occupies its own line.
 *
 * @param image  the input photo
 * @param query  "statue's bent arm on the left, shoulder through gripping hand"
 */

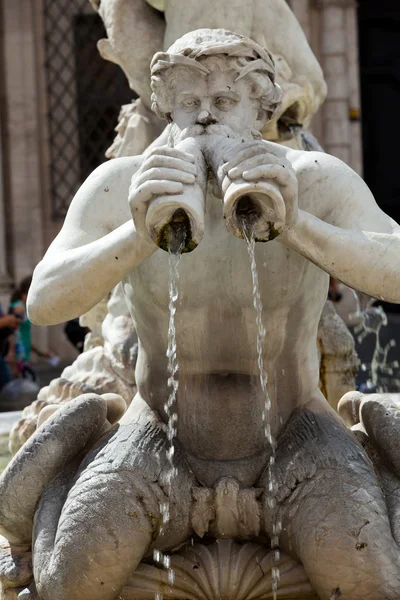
xmin=27 ymin=146 xmax=197 ymax=325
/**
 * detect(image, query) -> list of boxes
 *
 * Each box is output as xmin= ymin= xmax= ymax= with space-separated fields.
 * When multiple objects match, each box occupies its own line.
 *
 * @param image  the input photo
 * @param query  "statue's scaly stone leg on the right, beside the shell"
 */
xmin=261 ymin=409 xmax=400 ymax=600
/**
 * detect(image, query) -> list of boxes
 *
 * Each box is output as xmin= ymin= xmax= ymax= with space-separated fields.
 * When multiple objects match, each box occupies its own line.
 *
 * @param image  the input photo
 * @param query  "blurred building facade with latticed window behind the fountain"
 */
xmin=0 ymin=0 xmax=400 ymax=354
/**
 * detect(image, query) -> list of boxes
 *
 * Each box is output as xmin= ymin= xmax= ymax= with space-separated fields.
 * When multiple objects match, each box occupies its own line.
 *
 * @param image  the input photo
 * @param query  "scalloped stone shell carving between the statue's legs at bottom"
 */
xmin=121 ymin=540 xmax=318 ymax=600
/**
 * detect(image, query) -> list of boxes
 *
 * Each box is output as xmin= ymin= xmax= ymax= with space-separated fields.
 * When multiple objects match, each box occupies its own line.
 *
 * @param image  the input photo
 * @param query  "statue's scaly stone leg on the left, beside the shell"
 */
xmin=33 ymin=404 xmax=194 ymax=600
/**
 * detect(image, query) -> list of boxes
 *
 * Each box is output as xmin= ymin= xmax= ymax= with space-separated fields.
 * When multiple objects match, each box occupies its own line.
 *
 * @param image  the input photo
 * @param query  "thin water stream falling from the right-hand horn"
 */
xmin=242 ymin=222 xmax=282 ymax=600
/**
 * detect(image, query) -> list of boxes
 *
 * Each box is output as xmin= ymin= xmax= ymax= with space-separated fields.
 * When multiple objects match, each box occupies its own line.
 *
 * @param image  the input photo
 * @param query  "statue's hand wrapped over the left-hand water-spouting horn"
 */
xmin=128 ymin=146 xmax=197 ymax=244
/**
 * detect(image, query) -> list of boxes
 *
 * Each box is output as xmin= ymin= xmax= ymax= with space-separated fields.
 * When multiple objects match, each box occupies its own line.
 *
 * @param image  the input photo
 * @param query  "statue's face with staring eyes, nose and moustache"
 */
xmin=172 ymin=70 xmax=259 ymax=134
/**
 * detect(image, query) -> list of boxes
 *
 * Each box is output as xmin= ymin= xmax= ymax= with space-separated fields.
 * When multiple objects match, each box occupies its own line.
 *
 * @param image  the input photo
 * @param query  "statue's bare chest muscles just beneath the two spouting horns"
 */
xmin=129 ymin=209 xmax=310 ymax=308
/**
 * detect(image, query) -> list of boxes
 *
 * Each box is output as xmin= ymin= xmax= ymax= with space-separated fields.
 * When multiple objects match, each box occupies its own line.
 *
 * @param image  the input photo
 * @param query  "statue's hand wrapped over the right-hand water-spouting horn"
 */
xmin=222 ymin=141 xmax=298 ymax=226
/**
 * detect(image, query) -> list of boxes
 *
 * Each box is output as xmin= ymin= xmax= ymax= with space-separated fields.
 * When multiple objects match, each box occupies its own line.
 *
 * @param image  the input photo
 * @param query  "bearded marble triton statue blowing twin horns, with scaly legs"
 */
xmin=0 ymin=29 xmax=400 ymax=600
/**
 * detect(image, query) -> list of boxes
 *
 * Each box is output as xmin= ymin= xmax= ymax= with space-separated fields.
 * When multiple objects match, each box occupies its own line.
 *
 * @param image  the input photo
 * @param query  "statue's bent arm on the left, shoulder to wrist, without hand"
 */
xmin=27 ymin=157 xmax=152 ymax=325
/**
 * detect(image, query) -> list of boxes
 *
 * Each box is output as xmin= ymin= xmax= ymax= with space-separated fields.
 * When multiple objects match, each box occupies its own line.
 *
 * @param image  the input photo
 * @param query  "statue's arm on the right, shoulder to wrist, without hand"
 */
xmin=277 ymin=152 xmax=400 ymax=303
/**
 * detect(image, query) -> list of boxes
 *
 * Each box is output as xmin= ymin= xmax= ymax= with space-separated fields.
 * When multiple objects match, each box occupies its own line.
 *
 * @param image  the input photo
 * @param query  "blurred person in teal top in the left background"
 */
xmin=9 ymin=275 xmax=52 ymax=381
